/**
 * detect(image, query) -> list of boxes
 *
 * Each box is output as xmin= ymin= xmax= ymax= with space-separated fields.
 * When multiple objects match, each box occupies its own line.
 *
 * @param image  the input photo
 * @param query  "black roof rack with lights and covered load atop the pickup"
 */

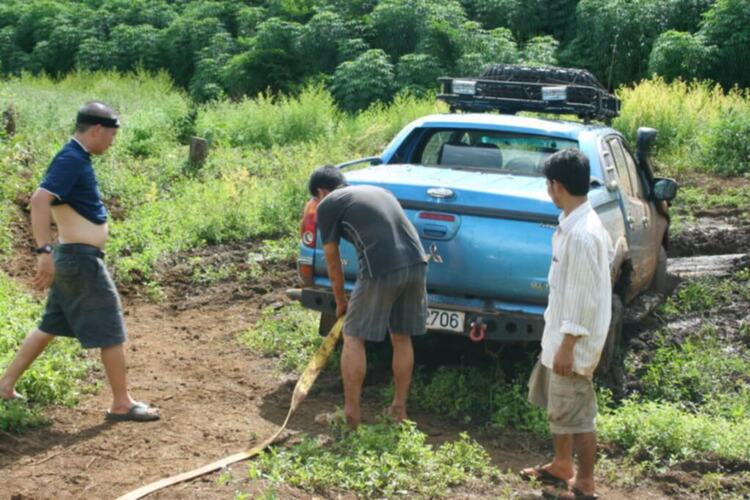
xmin=437 ymin=64 xmax=620 ymax=123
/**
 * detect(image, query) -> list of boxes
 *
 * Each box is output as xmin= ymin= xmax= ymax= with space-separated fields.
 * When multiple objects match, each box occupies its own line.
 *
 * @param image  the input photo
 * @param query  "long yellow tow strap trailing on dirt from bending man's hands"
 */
xmin=118 ymin=317 xmax=344 ymax=500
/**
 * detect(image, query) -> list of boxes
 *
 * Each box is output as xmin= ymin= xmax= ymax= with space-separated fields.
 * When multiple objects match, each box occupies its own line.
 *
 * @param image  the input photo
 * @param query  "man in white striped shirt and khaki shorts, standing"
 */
xmin=521 ymin=149 xmax=613 ymax=499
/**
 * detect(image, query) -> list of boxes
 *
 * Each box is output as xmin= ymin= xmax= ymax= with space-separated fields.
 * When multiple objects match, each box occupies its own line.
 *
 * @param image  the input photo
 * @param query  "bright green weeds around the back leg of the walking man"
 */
xmin=0 ymin=271 xmax=90 ymax=432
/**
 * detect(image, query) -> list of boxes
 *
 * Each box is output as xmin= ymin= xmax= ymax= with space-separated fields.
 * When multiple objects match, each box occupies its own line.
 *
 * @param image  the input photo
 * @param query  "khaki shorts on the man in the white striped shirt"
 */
xmin=529 ymin=361 xmax=597 ymax=434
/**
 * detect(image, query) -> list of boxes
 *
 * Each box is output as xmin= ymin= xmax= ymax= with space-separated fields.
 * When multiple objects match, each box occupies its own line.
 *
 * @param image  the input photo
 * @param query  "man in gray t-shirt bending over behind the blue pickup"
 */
xmin=309 ymin=166 xmax=427 ymax=427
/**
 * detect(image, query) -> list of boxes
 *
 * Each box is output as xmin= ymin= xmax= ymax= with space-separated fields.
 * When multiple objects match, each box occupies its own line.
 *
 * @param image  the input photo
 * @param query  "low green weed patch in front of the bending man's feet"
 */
xmin=249 ymin=422 xmax=500 ymax=498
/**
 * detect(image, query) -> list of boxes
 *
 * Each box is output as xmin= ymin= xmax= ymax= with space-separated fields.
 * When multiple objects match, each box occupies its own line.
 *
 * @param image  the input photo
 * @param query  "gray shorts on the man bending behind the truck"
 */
xmin=344 ymin=263 xmax=427 ymax=342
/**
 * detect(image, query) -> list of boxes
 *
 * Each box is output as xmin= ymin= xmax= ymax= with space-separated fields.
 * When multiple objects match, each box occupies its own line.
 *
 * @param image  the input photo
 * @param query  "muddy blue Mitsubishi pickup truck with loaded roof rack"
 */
xmin=290 ymin=68 xmax=677 ymax=372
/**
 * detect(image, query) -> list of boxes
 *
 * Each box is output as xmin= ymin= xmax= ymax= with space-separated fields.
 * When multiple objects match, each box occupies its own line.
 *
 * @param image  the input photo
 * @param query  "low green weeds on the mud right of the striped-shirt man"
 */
xmin=598 ymin=269 xmax=750 ymax=466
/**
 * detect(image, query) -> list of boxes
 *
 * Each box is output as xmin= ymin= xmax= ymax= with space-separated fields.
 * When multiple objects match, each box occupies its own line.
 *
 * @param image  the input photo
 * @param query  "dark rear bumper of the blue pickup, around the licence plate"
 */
xmin=287 ymin=288 xmax=544 ymax=342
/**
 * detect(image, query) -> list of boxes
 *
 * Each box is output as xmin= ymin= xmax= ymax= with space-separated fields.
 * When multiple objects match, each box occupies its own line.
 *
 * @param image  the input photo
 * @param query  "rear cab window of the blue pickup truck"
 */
xmin=413 ymin=129 xmax=578 ymax=176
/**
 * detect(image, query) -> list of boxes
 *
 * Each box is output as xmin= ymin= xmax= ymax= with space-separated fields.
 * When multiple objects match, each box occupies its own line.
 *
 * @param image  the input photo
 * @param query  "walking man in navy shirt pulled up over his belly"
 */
xmin=0 ymin=102 xmax=159 ymax=422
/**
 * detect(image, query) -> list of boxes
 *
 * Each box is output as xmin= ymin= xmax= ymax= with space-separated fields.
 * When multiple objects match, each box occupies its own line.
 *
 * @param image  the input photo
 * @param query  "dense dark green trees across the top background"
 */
xmin=0 ymin=0 xmax=750 ymax=110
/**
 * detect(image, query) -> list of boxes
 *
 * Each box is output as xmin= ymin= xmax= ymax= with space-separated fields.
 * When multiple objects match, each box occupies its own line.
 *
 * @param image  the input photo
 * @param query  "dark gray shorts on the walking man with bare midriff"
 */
xmin=39 ymin=244 xmax=127 ymax=349
